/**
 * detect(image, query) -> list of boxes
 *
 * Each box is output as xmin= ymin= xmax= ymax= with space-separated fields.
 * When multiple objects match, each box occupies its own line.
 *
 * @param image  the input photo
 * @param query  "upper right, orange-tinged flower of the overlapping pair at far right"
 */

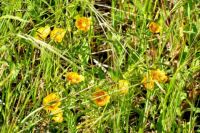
xmin=151 ymin=69 xmax=168 ymax=83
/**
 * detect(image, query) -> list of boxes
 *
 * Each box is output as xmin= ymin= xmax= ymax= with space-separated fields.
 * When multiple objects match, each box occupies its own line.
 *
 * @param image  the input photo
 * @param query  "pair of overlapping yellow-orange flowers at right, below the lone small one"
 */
xmin=142 ymin=69 xmax=168 ymax=90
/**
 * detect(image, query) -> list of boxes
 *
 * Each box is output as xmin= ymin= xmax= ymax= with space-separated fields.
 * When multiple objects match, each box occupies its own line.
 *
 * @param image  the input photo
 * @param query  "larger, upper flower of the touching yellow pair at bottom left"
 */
xmin=43 ymin=93 xmax=61 ymax=111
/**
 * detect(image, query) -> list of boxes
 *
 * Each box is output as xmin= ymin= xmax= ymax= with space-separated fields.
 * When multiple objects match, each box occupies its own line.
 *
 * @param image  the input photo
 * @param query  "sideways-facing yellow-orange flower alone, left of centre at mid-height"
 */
xmin=66 ymin=72 xmax=85 ymax=84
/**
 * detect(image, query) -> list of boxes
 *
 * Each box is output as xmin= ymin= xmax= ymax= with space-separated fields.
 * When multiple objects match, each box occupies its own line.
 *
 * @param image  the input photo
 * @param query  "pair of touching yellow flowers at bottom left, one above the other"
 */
xmin=43 ymin=93 xmax=63 ymax=123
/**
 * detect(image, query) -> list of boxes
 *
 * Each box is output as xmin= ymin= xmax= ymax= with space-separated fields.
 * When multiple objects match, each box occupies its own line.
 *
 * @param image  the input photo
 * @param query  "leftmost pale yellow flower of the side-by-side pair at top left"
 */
xmin=35 ymin=25 xmax=51 ymax=40
